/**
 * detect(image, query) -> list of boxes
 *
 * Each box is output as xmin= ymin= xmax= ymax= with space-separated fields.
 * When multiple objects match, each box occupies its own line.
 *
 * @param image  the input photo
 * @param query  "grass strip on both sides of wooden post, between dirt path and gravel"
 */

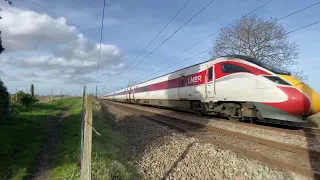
xmin=50 ymin=99 xmax=139 ymax=180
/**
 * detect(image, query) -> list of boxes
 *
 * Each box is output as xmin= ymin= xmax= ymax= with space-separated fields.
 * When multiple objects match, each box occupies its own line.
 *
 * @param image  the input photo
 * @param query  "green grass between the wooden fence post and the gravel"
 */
xmin=92 ymin=102 xmax=140 ymax=179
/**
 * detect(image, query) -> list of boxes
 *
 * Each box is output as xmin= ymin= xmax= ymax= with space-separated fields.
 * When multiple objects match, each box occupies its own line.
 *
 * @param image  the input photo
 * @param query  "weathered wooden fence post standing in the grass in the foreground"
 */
xmin=81 ymin=96 xmax=93 ymax=180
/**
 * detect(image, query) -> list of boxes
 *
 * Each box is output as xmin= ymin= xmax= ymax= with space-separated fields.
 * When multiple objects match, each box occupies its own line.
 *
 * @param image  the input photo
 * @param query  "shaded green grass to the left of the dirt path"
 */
xmin=0 ymin=99 xmax=77 ymax=180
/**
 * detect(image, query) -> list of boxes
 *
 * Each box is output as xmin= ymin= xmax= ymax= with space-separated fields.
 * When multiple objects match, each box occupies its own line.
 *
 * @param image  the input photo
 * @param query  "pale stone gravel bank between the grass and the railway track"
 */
xmin=102 ymin=101 xmax=308 ymax=180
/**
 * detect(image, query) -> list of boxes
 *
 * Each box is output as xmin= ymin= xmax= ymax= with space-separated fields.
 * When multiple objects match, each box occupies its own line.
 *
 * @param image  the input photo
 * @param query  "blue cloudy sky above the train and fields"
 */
xmin=0 ymin=0 xmax=320 ymax=95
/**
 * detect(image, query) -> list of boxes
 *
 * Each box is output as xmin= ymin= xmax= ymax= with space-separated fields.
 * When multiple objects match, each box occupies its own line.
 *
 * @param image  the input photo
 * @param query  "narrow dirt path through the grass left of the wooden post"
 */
xmin=26 ymin=109 xmax=68 ymax=180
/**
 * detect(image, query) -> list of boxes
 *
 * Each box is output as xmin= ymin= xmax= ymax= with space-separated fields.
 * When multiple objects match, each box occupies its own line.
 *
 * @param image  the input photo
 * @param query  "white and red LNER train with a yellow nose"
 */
xmin=102 ymin=55 xmax=320 ymax=124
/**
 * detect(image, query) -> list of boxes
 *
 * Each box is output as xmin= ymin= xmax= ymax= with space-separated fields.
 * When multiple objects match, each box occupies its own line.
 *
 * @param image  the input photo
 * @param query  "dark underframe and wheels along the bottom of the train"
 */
xmin=110 ymin=99 xmax=306 ymax=127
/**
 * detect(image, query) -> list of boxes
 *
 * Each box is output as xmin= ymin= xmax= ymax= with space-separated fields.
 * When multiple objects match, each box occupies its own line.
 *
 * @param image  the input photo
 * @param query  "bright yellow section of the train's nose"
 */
xmin=281 ymin=75 xmax=320 ymax=116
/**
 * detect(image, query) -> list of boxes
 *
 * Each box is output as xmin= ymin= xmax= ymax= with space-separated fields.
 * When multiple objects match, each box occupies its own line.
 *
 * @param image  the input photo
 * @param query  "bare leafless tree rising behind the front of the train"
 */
xmin=210 ymin=15 xmax=306 ymax=79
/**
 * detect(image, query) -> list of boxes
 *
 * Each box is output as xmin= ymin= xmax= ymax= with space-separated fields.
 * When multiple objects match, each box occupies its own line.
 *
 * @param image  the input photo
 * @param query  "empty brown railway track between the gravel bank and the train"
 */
xmin=104 ymin=101 xmax=320 ymax=179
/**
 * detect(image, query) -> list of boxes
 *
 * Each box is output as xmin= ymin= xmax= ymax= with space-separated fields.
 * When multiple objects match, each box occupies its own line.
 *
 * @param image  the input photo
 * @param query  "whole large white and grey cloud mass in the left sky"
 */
xmin=0 ymin=8 xmax=124 ymax=84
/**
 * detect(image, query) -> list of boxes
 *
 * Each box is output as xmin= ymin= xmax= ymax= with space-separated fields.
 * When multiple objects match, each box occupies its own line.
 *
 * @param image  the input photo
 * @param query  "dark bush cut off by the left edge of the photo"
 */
xmin=0 ymin=79 xmax=10 ymax=122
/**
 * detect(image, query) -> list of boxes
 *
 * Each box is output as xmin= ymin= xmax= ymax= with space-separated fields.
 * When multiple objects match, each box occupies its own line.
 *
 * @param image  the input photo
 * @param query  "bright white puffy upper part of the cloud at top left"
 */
xmin=0 ymin=7 xmax=78 ymax=52
